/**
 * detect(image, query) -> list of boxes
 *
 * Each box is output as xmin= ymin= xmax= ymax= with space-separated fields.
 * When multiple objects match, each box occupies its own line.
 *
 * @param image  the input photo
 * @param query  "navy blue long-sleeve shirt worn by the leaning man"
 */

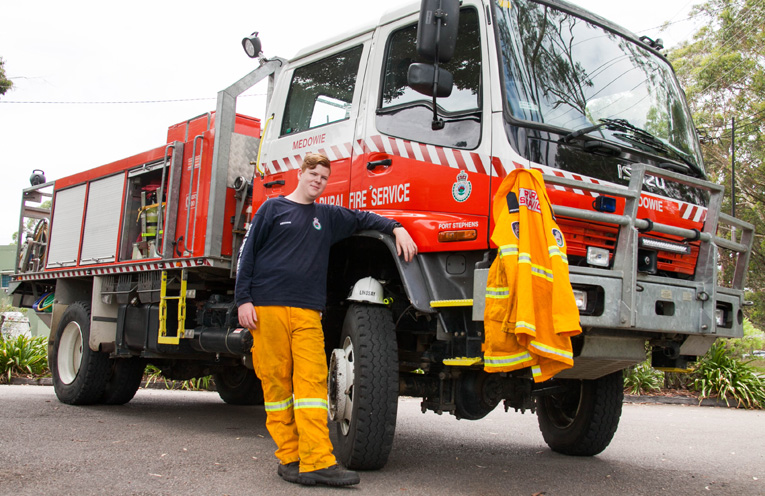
xmin=235 ymin=197 xmax=396 ymax=310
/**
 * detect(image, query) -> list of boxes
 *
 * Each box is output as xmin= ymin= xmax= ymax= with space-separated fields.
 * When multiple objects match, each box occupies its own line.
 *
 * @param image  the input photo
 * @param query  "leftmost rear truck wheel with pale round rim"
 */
xmin=49 ymin=301 xmax=109 ymax=405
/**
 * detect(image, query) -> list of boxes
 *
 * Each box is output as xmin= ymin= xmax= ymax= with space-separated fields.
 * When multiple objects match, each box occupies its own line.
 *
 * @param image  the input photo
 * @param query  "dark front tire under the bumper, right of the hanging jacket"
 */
xmin=537 ymin=371 xmax=624 ymax=456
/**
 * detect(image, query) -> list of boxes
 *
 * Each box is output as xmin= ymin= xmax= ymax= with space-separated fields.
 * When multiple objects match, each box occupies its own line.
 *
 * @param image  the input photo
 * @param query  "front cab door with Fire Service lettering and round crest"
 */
xmin=349 ymin=2 xmax=491 ymax=251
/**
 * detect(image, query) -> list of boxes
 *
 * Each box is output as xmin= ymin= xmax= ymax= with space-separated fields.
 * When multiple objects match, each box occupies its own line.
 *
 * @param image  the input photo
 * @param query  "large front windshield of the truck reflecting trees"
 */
xmin=496 ymin=0 xmax=701 ymax=168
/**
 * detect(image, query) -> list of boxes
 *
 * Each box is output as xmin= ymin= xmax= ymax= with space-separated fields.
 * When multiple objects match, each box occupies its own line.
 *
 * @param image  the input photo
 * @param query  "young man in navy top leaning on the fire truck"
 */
xmin=236 ymin=153 xmax=417 ymax=486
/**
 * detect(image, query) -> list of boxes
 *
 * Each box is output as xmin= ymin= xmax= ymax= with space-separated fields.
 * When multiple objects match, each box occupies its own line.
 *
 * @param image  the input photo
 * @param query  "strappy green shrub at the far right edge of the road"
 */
xmin=691 ymin=341 xmax=765 ymax=408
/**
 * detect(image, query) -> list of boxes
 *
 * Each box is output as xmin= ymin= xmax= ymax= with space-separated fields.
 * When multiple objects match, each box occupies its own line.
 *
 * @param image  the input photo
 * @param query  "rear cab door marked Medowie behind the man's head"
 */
xmin=255 ymin=30 xmax=372 ymax=208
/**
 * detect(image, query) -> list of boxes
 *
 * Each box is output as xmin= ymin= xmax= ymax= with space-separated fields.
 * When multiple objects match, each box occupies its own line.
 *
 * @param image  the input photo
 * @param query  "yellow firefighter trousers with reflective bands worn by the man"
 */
xmin=250 ymin=306 xmax=337 ymax=472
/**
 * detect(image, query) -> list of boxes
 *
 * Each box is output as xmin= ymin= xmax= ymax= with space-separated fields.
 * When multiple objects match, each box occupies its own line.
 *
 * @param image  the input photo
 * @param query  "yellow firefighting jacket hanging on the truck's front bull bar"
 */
xmin=483 ymin=169 xmax=582 ymax=382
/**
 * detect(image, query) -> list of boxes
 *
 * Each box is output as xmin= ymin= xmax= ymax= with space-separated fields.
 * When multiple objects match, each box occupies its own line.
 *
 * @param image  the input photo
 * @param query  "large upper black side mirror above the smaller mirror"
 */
xmin=417 ymin=0 xmax=460 ymax=62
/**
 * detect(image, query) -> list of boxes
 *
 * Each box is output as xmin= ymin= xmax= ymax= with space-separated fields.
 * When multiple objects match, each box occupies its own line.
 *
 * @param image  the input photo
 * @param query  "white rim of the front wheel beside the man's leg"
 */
xmin=328 ymin=337 xmax=356 ymax=436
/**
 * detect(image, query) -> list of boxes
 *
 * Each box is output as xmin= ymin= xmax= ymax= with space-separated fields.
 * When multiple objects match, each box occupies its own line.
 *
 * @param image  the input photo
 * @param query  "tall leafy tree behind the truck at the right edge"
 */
xmin=668 ymin=0 xmax=765 ymax=327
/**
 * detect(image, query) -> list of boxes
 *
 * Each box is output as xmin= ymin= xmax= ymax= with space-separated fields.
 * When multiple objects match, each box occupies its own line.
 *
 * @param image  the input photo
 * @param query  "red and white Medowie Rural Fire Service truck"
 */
xmin=11 ymin=0 xmax=754 ymax=469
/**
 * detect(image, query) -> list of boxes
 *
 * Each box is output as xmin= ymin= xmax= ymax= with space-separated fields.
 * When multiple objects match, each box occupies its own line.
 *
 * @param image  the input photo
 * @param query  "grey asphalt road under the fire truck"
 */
xmin=0 ymin=385 xmax=765 ymax=496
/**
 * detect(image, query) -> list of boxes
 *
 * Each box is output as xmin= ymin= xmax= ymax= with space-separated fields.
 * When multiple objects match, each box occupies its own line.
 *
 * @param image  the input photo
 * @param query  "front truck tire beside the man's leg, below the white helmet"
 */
xmin=330 ymin=304 xmax=398 ymax=470
